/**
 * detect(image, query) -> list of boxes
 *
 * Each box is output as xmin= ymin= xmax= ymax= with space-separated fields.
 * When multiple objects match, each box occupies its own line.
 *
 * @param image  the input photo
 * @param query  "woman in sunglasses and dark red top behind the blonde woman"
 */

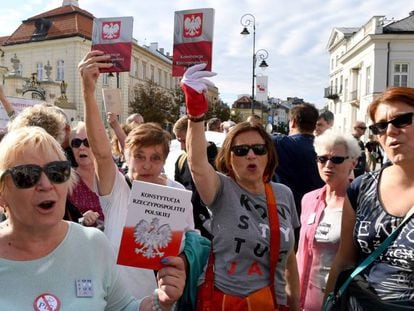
xmin=68 ymin=121 xmax=104 ymax=229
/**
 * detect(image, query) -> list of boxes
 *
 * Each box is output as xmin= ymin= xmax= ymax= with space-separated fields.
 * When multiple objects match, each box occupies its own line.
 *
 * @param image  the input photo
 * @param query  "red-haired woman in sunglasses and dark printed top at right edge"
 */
xmin=326 ymin=87 xmax=414 ymax=310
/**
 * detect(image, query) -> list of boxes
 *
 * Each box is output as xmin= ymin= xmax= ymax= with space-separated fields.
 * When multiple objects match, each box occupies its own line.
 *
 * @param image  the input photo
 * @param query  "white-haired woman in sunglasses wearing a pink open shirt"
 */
xmin=296 ymin=131 xmax=361 ymax=311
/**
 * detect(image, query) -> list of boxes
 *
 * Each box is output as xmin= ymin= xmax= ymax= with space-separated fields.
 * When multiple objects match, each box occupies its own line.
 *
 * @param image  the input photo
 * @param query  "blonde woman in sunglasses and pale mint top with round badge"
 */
xmin=0 ymin=127 xmax=185 ymax=311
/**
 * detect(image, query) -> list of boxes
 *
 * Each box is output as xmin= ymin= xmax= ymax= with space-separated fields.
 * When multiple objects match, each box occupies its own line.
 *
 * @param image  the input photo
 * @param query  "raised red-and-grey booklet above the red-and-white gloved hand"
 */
xmin=172 ymin=8 xmax=214 ymax=77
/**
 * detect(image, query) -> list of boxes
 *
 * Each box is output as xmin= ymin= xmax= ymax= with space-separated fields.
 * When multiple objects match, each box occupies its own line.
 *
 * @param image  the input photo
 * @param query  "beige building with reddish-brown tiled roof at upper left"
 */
xmin=0 ymin=0 xmax=207 ymax=121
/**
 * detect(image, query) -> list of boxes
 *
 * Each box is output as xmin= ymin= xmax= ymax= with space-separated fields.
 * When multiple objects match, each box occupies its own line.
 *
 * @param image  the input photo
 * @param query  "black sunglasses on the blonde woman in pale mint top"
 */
xmin=1 ymin=161 xmax=71 ymax=189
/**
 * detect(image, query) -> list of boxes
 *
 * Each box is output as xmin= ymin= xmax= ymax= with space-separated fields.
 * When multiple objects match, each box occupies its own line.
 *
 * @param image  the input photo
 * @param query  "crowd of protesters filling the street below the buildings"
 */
xmin=0 ymin=56 xmax=414 ymax=311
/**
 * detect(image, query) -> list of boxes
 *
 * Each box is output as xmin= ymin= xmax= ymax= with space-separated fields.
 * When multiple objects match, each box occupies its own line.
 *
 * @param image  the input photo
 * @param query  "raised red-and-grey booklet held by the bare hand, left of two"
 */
xmin=92 ymin=16 xmax=134 ymax=72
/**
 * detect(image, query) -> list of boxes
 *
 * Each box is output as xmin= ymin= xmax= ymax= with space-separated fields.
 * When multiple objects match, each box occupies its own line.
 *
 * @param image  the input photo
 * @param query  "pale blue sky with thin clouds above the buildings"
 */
xmin=0 ymin=0 xmax=414 ymax=107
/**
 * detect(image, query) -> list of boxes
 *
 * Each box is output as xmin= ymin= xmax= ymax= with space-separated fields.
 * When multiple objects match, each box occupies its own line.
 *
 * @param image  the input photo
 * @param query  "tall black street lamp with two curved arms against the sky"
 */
xmin=240 ymin=13 xmax=269 ymax=115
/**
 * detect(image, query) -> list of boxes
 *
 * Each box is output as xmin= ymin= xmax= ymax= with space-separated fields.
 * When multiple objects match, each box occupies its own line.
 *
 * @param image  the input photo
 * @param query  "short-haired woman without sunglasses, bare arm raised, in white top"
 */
xmin=79 ymin=50 xmax=208 ymax=308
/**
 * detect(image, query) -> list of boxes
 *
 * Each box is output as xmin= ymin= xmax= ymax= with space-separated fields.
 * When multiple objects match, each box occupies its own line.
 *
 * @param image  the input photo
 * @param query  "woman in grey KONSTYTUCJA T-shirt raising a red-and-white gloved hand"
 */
xmin=181 ymin=64 xmax=299 ymax=311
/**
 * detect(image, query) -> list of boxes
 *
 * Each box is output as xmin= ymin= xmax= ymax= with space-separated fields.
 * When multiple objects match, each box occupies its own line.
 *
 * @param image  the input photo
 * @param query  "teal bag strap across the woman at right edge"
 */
xmin=337 ymin=205 xmax=414 ymax=297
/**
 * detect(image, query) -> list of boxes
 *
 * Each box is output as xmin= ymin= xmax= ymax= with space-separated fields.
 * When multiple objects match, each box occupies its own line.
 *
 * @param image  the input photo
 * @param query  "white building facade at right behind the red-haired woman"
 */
xmin=325 ymin=11 xmax=414 ymax=136
